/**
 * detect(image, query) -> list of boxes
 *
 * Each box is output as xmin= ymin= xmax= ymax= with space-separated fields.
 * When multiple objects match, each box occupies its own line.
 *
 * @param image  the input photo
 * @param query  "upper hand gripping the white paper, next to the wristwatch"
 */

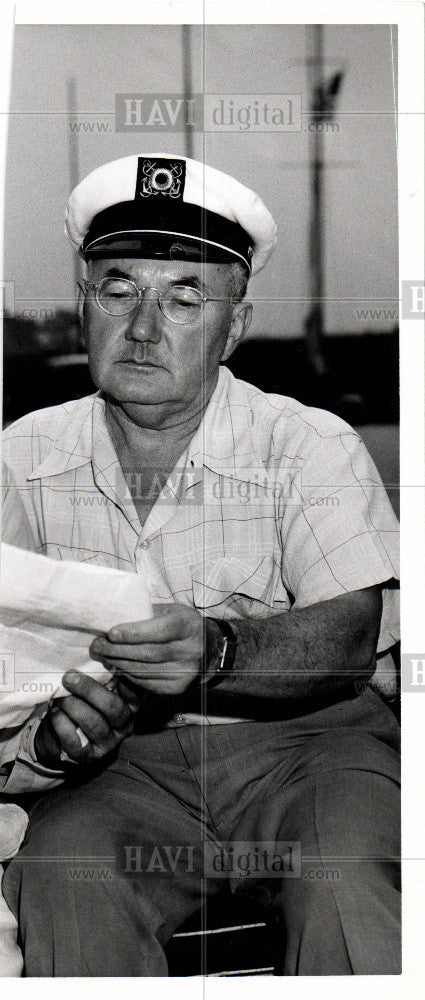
xmin=90 ymin=604 xmax=204 ymax=695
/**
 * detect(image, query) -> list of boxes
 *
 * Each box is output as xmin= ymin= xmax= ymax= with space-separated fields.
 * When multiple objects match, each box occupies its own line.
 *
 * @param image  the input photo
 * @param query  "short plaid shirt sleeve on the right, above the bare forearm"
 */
xmin=281 ymin=430 xmax=399 ymax=652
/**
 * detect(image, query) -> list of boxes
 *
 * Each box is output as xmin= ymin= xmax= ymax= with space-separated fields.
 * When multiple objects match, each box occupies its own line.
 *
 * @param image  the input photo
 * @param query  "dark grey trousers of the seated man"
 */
xmin=3 ymin=689 xmax=400 ymax=977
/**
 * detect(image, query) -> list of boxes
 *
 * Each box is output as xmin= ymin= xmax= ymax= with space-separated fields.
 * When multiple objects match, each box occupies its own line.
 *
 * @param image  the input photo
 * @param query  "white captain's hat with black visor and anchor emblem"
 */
xmin=65 ymin=153 xmax=276 ymax=274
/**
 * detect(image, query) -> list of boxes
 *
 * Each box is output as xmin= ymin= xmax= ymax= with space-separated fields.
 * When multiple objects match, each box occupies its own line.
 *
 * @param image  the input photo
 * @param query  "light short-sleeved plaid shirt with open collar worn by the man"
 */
xmin=3 ymin=367 xmax=398 ymax=792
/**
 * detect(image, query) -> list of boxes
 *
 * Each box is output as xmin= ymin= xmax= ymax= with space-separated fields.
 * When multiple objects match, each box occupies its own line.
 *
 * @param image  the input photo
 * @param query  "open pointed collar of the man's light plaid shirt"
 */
xmin=28 ymin=366 xmax=265 ymax=483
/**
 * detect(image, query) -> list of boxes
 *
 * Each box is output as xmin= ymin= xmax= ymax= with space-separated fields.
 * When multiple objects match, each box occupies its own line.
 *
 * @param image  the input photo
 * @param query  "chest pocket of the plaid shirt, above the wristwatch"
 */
xmin=191 ymin=556 xmax=290 ymax=618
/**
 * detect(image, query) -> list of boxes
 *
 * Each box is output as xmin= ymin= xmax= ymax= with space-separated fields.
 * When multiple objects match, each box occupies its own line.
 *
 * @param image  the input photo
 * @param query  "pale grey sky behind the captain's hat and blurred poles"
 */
xmin=5 ymin=19 xmax=398 ymax=338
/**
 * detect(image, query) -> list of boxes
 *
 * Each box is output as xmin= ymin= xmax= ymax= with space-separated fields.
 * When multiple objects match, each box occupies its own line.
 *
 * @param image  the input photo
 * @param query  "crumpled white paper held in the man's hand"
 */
xmin=0 ymin=544 xmax=152 ymax=727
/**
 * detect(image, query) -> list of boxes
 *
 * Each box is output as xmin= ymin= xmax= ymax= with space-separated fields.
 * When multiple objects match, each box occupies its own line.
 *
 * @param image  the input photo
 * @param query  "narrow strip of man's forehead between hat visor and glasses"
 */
xmin=90 ymin=256 xmax=232 ymax=285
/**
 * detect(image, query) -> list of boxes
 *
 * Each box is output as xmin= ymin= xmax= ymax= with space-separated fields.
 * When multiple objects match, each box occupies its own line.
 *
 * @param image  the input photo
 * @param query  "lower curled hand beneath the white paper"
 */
xmin=35 ymin=671 xmax=139 ymax=770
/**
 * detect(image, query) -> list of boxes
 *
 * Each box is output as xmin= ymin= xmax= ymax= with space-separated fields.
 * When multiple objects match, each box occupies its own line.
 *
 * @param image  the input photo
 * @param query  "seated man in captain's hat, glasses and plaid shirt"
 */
xmin=3 ymin=156 xmax=400 ymax=976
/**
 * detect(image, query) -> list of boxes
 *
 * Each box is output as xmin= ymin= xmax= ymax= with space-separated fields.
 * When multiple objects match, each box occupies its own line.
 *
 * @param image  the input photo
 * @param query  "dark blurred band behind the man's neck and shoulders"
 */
xmin=3 ymin=311 xmax=399 ymax=425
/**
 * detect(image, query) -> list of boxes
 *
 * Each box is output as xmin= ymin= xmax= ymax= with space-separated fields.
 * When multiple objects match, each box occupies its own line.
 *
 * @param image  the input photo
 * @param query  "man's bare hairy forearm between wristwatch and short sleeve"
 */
xmin=205 ymin=587 xmax=382 ymax=701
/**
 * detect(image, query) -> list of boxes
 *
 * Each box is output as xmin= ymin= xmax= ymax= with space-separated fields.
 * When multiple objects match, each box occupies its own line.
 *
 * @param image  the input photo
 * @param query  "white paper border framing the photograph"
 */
xmin=0 ymin=0 xmax=425 ymax=1000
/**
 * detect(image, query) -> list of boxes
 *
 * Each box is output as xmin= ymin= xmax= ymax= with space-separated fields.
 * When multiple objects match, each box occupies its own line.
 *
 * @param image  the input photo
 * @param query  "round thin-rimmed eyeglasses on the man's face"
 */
xmin=84 ymin=278 xmax=222 ymax=325
